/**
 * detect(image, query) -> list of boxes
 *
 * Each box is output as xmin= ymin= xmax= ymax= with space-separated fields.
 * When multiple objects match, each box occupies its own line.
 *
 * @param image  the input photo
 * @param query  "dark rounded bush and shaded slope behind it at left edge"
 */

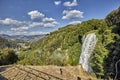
xmin=0 ymin=37 xmax=20 ymax=65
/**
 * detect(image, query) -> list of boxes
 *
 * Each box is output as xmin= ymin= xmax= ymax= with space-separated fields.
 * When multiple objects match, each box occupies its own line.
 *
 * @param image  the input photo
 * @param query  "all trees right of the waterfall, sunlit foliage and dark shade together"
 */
xmin=91 ymin=6 xmax=120 ymax=79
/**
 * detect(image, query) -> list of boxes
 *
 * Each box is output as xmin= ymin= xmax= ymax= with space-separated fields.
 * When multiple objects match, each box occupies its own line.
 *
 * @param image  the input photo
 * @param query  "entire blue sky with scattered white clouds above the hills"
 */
xmin=0 ymin=0 xmax=120 ymax=35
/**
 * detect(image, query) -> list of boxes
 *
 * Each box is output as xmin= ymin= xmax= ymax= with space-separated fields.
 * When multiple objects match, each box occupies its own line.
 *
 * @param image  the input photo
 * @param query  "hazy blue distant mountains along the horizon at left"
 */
xmin=0 ymin=34 xmax=45 ymax=41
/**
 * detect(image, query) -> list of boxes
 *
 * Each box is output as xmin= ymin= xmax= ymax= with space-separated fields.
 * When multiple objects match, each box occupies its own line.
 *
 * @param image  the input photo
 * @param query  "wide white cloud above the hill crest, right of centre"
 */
xmin=62 ymin=10 xmax=83 ymax=19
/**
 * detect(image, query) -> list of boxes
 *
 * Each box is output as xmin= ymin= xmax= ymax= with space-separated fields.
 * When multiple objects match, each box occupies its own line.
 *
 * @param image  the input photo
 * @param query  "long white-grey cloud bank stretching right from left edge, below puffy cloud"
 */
xmin=0 ymin=17 xmax=58 ymax=31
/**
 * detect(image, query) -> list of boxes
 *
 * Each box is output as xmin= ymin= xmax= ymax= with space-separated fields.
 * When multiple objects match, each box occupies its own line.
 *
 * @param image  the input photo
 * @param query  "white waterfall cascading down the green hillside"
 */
xmin=79 ymin=33 xmax=98 ymax=72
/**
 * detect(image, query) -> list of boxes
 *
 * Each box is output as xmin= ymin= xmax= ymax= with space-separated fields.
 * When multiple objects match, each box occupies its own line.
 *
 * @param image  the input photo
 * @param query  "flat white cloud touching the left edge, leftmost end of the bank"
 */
xmin=0 ymin=18 xmax=22 ymax=26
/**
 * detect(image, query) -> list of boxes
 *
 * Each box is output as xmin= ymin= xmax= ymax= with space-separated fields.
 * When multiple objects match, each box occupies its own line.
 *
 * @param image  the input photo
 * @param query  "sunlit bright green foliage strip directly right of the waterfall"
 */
xmin=91 ymin=30 xmax=114 ymax=78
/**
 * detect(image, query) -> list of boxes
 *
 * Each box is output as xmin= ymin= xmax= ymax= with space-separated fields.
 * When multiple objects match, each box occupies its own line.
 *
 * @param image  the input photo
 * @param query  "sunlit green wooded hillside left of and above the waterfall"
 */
xmin=18 ymin=19 xmax=108 ymax=66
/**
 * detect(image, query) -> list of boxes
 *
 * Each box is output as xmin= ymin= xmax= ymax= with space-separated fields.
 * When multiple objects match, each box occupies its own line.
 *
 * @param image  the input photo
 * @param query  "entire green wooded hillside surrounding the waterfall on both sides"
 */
xmin=0 ymin=8 xmax=120 ymax=79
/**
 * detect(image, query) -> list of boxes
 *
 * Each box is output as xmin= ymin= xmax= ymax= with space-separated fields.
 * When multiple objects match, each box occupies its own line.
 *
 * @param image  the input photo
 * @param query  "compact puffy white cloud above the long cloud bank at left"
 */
xmin=28 ymin=10 xmax=45 ymax=20
